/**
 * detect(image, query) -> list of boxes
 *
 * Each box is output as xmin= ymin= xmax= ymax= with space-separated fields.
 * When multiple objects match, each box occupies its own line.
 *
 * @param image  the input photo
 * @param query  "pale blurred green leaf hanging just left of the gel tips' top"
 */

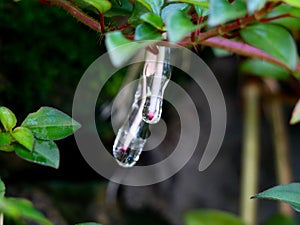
xmin=105 ymin=31 xmax=151 ymax=67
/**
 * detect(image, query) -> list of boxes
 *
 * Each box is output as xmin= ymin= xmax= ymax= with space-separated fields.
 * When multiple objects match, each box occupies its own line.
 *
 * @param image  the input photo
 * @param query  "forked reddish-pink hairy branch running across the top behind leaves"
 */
xmin=48 ymin=0 xmax=300 ymax=73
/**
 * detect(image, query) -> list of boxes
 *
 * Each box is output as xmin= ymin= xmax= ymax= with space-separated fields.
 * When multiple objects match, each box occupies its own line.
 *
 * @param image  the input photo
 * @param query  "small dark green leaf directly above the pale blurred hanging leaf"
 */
xmin=134 ymin=23 xmax=162 ymax=41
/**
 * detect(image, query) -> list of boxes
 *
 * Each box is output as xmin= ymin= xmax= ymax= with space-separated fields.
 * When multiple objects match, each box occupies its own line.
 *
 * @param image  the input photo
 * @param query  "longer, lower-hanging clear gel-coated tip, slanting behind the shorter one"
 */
xmin=113 ymin=79 xmax=149 ymax=167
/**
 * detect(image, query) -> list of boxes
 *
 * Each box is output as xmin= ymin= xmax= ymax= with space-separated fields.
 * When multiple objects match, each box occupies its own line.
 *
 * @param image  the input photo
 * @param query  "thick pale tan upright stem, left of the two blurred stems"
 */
xmin=241 ymin=82 xmax=260 ymax=225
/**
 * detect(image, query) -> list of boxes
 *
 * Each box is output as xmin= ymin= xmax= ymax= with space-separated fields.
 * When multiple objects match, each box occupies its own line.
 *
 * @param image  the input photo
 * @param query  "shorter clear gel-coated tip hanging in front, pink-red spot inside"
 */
xmin=143 ymin=46 xmax=171 ymax=124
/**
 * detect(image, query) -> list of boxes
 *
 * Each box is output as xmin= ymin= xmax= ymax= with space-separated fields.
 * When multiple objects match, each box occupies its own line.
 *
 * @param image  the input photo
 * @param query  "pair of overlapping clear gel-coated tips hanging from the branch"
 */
xmin=113 ymin=43 xmax=171 ymax=167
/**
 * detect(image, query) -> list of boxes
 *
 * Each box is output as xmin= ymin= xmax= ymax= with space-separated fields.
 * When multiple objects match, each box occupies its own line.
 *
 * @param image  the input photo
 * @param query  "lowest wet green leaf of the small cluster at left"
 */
xmin=15 ymin=139 xmax=59 ymax=169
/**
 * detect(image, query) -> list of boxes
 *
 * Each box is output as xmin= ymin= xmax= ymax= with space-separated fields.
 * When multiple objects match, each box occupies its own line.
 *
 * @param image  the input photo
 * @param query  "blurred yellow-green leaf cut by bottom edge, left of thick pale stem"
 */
xmin=184 ymin=210 xmax=244 ymax=225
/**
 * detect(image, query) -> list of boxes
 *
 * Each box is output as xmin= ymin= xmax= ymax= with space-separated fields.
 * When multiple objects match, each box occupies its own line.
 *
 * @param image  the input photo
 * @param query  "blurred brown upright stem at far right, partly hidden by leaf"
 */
xmin=265 ymin=79 xmax=293 ymax=216
